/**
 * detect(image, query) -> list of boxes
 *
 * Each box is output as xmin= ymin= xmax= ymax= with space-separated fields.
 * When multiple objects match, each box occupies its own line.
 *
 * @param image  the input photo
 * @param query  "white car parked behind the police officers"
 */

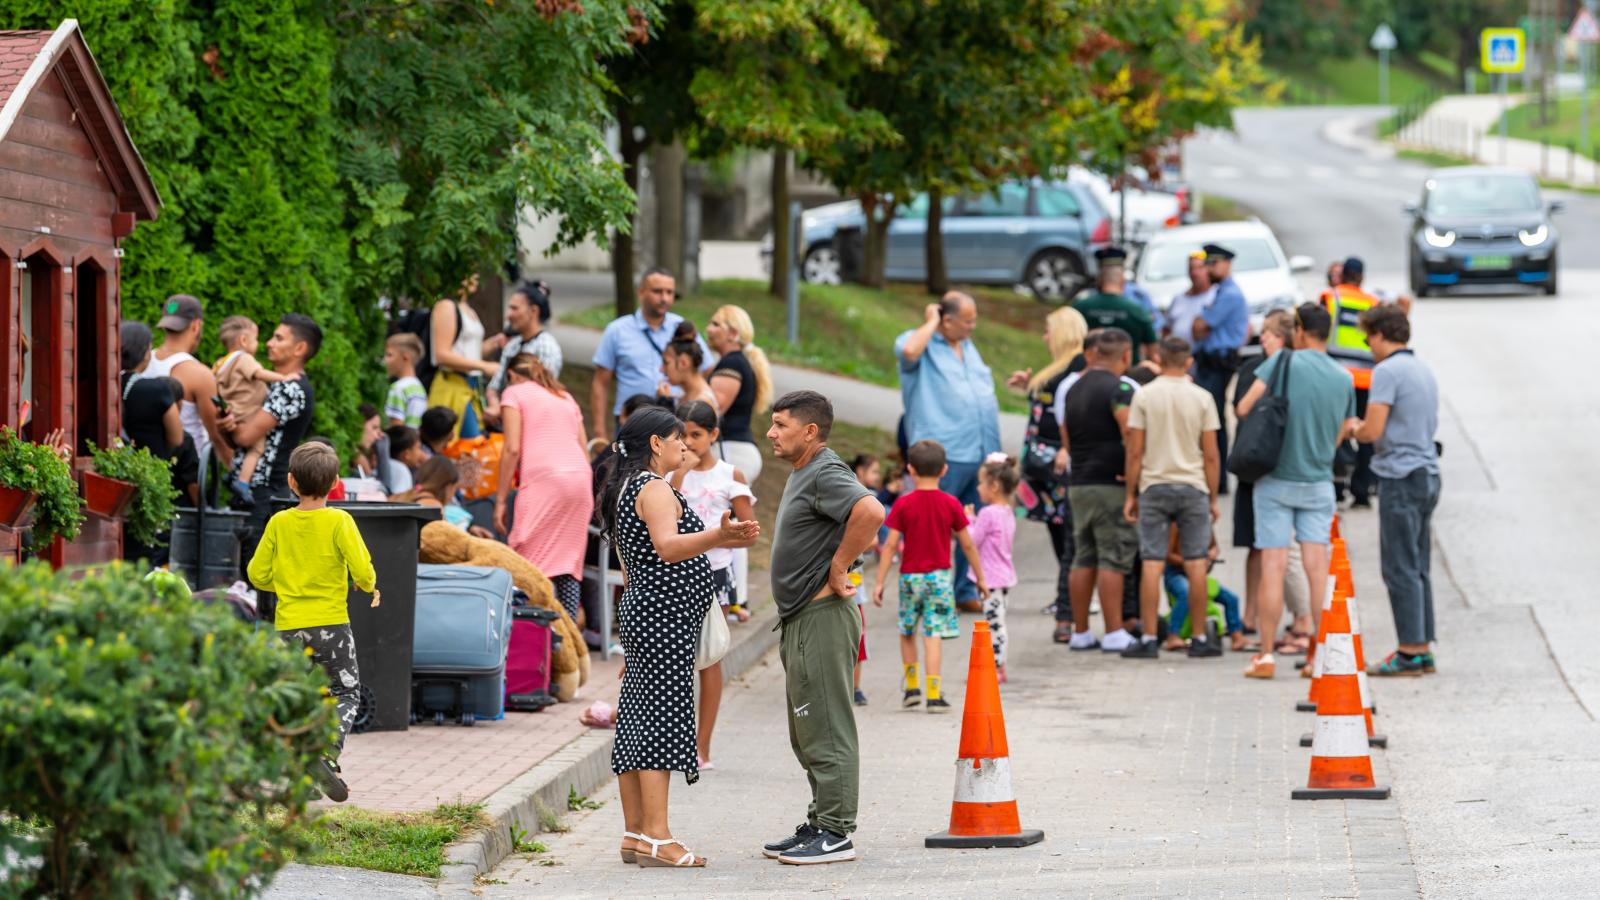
xmin=1133 ymin=219 xmax=1315 ymax=341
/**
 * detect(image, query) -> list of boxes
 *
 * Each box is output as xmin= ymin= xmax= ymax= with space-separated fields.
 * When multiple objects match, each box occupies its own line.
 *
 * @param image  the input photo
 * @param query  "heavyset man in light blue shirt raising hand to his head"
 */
xmin=894 ymin=290 xmax=1000 ymax=604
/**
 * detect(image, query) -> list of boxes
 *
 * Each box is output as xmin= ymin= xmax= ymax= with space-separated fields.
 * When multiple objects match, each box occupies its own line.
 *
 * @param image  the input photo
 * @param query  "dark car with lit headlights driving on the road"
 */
xmin=1405 ymin=167 xmax=1562 ymax=296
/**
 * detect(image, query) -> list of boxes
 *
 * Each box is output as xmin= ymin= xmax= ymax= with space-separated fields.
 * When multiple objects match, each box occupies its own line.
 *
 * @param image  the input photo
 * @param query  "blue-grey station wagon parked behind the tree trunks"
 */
xmin=762 ymin=179 xmax=1112 ymax=303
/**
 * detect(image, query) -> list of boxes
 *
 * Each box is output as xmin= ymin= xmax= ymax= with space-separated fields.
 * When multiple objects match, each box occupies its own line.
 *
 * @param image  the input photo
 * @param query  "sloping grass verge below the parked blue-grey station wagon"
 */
xmin=568 ymin=279 xmax=1051 ymax=413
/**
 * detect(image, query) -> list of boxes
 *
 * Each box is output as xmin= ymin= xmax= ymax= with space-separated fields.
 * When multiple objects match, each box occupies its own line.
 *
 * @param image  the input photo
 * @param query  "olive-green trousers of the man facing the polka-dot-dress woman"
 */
xmin=778 ymin=597 xmax=861 ymax=834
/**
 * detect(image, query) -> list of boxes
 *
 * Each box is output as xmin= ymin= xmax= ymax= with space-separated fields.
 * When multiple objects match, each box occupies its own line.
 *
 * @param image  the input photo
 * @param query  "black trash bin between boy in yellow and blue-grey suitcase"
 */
xmin=274 ymin=500 xmax=440 ymax=732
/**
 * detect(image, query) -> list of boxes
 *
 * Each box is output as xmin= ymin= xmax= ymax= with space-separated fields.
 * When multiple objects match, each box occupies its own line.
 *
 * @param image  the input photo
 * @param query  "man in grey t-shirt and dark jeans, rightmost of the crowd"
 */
xmin=1355 ymin=304 xmax=1440 ymax=676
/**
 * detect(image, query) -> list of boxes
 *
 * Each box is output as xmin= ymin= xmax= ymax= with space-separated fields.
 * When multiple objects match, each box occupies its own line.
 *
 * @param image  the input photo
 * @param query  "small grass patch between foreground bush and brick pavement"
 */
xmin=246 ymin=804 xmax=488 ymax=878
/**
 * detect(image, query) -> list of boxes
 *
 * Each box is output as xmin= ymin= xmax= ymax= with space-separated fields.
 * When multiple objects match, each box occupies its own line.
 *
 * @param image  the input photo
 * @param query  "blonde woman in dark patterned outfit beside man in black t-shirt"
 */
xmin=1006 ymin=306 xmax=1090 ymax=642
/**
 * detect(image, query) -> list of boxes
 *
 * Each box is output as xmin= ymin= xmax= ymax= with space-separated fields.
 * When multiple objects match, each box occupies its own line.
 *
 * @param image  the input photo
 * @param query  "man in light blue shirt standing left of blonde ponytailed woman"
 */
xmin=589 ymin=266 xmax=712 ymax=440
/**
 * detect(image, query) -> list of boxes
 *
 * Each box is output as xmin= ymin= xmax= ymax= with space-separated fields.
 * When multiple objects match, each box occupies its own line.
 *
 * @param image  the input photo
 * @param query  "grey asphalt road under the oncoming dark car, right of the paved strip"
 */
xmin=1187 ymin=109 xmax=1600 ymax=897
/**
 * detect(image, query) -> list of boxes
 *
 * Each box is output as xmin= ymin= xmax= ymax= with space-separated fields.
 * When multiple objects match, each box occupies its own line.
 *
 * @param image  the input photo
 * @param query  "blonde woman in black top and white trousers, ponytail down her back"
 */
xmin=706 ymin=304 xmax=773 ymax=484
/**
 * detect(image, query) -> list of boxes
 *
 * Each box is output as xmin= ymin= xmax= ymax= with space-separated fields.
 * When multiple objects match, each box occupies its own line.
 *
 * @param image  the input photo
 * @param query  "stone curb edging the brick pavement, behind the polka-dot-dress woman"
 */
xmin=440 ymin=599 xmax=778 ymax=889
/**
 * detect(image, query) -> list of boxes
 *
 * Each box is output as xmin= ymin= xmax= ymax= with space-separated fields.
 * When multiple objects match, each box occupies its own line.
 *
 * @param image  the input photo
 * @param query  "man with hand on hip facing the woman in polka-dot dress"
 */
xmin=762 ymin=391 xmax=883 ymax=865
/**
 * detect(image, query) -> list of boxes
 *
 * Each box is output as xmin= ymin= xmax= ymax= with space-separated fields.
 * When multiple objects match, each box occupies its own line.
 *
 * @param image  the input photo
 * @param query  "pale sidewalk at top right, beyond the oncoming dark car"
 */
xmin=1394 ymin=94 xmax=1600 ymax=186
